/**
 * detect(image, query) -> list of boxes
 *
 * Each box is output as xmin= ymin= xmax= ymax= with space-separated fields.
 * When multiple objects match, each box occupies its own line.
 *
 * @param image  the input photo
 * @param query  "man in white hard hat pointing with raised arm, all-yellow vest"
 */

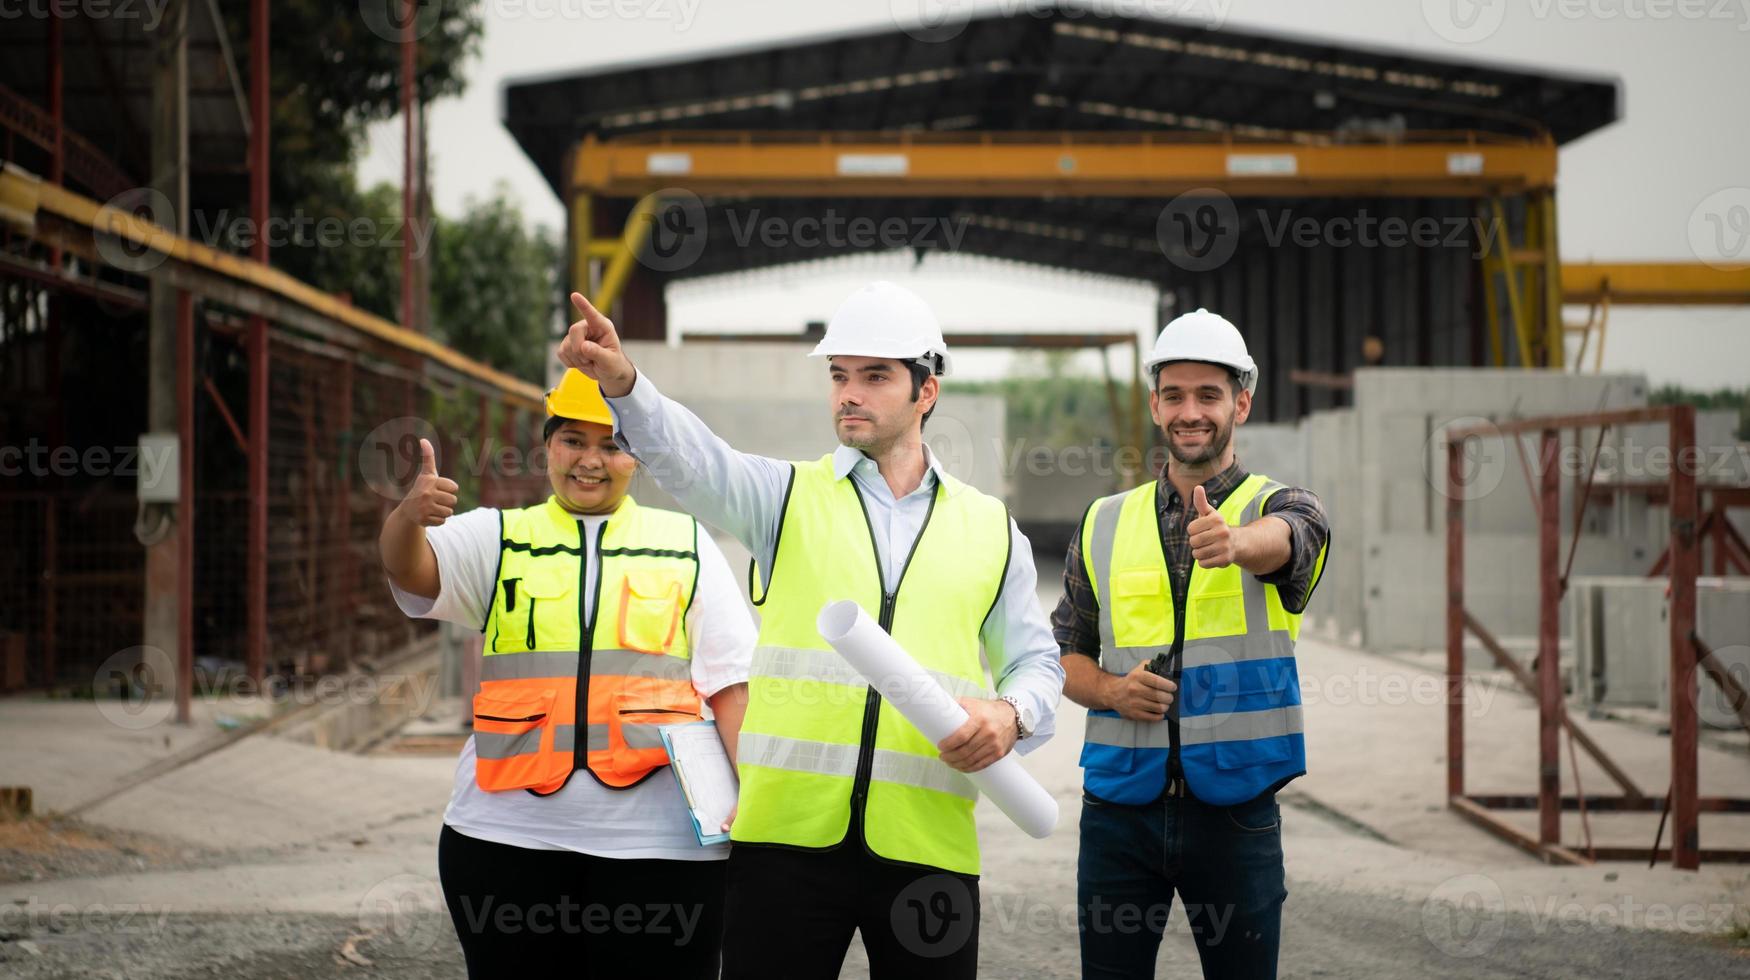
xmin=560 ymin=282 xmax=1064 ymax=978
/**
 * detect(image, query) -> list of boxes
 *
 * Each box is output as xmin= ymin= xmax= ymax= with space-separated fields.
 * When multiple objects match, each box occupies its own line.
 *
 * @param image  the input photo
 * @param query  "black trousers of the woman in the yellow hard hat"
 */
xmin=438 ymin=826 xmax=725 ymax=980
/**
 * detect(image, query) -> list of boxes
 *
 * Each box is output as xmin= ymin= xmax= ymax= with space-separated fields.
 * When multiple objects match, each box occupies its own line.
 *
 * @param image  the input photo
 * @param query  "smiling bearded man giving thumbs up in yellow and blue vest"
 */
xmin=1052 ymin=310 xmax=1330 ymax=978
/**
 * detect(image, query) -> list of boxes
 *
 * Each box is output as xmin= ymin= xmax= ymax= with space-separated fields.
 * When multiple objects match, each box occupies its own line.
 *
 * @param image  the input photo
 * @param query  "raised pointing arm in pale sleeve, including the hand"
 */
xmin=558 ymin=292 xmax=789 ymax=569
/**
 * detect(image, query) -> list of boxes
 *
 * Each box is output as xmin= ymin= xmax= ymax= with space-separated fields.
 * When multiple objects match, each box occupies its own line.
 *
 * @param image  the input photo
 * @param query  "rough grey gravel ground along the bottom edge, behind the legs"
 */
xmin=0 ymin=880 xmax=1750 ymax=980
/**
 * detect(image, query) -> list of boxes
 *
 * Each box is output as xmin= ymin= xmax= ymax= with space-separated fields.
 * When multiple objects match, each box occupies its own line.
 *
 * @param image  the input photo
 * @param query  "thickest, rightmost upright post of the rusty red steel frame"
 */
xmin=1671 ymin=404 xmax=1701 ymax=872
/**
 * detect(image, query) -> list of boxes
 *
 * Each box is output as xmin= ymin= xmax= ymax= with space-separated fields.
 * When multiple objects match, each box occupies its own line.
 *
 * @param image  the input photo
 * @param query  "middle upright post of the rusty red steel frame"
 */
xmin=1537 ymin=429 xmax=1561 ymax=845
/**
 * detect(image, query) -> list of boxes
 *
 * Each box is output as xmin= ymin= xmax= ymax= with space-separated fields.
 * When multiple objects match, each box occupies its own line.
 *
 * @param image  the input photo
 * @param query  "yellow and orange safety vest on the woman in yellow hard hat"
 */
xmin=474 ymin=497 xmax=700 ymax=796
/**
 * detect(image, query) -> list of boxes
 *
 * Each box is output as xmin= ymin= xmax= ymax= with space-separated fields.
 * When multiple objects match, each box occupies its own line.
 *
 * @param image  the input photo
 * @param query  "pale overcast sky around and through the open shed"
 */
xmin=362 ymin=0 xmax=1750 ymax=387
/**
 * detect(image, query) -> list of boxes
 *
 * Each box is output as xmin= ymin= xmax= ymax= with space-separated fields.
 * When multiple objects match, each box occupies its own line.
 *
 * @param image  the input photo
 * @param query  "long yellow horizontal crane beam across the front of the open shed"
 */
xmin=571 ymin=131 xmax=1556 ymax=198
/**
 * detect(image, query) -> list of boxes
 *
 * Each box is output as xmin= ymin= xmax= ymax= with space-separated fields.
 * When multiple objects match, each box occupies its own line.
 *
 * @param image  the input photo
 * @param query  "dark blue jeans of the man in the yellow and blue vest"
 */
xmin=1076 ymin=780 xmax=1288 ymax=980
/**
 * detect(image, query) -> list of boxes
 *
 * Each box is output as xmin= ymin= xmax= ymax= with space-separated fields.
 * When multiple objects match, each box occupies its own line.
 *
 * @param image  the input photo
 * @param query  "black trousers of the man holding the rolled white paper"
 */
xmin=723 ymin=826 xmax=978 ymax=980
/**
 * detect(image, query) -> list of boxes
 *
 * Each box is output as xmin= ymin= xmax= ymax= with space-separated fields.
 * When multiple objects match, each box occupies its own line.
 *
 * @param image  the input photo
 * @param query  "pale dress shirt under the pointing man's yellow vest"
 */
xmin=607 ymin=373 xmax=1064 ymax=754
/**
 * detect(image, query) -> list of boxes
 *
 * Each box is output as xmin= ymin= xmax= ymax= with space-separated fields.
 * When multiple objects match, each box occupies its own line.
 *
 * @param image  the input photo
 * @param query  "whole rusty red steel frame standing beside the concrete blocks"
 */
xmin=1446 ymin=406 xmax=1750 ymax=870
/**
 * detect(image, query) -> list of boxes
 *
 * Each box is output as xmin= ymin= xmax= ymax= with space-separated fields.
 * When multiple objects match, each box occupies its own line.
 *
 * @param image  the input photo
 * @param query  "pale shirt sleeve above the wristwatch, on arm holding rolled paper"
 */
xmin=978 ymin=518 xmax=1064 ymax=754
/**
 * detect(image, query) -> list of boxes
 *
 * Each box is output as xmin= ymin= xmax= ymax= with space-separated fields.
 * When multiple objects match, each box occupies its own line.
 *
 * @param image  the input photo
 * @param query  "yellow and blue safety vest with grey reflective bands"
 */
xmin=1082 ymin=474 xmax=1325 ymax=807
